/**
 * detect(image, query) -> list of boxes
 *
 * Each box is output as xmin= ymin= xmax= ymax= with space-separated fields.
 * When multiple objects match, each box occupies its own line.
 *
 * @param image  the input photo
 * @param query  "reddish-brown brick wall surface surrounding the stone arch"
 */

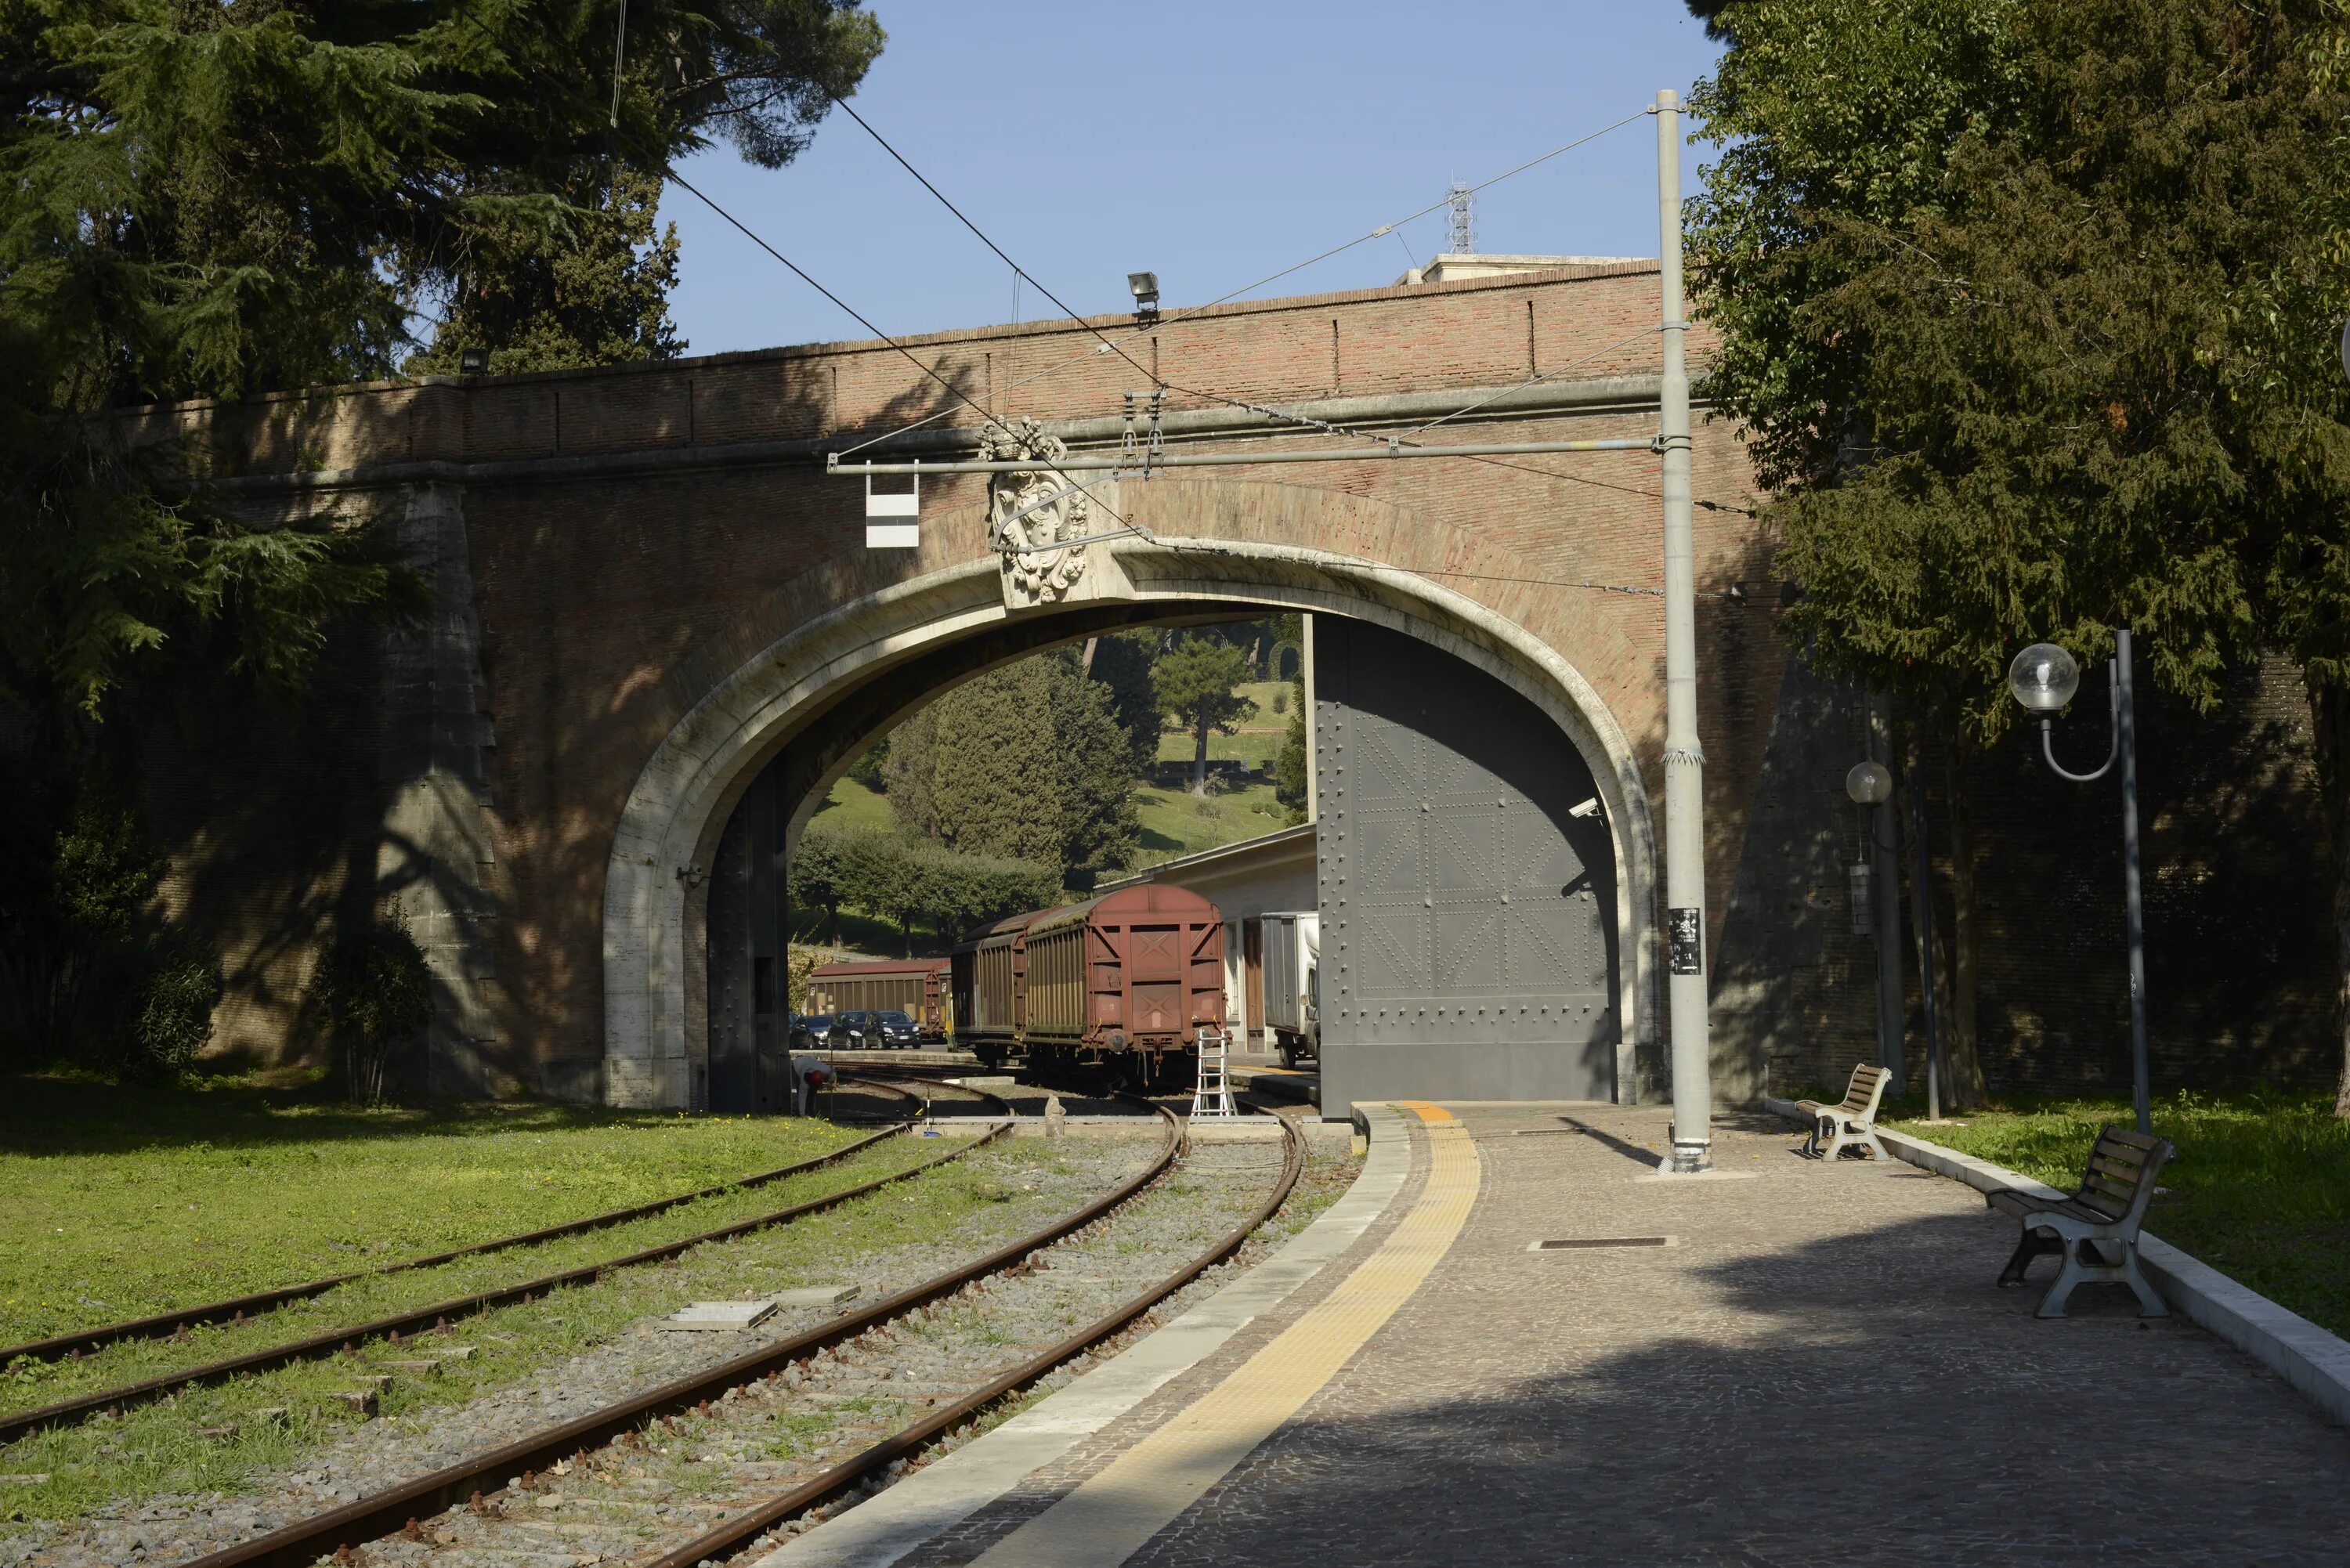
xmin=134 ymin=266 xmax=2322 ymax=1104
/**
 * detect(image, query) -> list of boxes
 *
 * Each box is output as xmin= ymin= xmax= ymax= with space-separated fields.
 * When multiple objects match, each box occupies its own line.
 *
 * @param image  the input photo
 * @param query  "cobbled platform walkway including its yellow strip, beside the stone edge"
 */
xmin=905 ymin=1107 xmax=2350 ymax=1568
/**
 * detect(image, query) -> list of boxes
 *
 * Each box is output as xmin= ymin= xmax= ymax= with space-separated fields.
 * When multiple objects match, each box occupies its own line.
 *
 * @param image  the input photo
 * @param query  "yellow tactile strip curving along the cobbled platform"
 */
xmin=975 ymin=1100 xmax=1478 ymax=1568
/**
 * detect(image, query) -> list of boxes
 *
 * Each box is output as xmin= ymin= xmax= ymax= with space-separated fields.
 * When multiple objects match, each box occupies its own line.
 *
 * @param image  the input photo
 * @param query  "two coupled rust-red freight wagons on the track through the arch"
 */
xmin=952 ymin=884 xmax=1224 ymax=1093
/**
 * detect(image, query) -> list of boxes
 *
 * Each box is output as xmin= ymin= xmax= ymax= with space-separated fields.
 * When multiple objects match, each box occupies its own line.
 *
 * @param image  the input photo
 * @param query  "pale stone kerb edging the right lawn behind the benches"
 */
xmin=1762 ymin=1096 xmax=2350 ymax=1427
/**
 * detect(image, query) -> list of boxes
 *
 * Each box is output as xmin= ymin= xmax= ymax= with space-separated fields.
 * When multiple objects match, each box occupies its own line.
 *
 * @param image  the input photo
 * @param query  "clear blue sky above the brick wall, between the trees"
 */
xmin=663 ymin=0 xmax=1716 ymax=355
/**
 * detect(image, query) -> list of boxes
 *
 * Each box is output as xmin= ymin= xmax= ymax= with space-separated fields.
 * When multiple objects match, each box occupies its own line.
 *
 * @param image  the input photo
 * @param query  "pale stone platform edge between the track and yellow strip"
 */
xmin=754 ymin=1105 xmax=1412 ymax=1568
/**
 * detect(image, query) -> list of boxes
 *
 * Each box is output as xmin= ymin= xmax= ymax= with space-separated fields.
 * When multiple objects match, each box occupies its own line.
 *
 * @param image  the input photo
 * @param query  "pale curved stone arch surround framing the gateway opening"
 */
xmin=604 ymin=479 xmax=1661 ymax=1107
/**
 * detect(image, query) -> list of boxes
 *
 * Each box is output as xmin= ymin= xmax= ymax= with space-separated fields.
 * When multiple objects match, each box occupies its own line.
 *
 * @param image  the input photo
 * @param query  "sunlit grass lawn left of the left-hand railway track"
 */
xmin=0 ymin=1077 xmax=855 ymax=1353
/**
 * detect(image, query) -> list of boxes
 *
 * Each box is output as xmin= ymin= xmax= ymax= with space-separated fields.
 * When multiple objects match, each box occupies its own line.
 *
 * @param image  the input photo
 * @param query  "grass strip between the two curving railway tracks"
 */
xmin=0 ymin=1140 xmax=1109 ymax=1519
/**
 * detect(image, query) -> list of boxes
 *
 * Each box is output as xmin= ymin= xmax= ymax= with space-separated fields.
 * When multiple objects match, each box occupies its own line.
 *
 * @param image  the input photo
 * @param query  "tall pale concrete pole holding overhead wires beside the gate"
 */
xmin=1654 ymin=89 xmax=1713 ymax=1173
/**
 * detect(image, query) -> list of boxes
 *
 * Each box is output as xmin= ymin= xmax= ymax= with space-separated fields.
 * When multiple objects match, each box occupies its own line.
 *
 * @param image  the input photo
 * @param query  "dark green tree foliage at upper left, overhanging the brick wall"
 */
xmin=0 ymin=0 xmax=881 ymax=740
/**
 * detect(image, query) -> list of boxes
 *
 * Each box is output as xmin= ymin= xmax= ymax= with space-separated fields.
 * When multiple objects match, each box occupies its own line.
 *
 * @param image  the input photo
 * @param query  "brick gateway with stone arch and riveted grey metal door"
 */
xmin=161 ymin=263 xmax=1795 ymax=1107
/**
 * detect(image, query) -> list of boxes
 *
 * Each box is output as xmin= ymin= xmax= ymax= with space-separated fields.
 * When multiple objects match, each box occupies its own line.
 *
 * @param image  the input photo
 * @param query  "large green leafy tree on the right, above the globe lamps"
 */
xmin=1694 ymin=0 xmax=2350 ymax=1098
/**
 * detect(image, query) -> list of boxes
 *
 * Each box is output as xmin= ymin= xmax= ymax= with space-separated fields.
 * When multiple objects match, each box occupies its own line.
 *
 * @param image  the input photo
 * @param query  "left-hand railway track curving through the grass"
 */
xmin=0 ymin=1082 xmax=1010 ymax=1443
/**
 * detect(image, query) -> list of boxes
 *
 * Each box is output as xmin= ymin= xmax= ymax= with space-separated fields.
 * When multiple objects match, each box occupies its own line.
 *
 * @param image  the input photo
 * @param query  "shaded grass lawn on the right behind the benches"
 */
xmin=1871 ymin=1091 xmax=2350 ymax=1335
